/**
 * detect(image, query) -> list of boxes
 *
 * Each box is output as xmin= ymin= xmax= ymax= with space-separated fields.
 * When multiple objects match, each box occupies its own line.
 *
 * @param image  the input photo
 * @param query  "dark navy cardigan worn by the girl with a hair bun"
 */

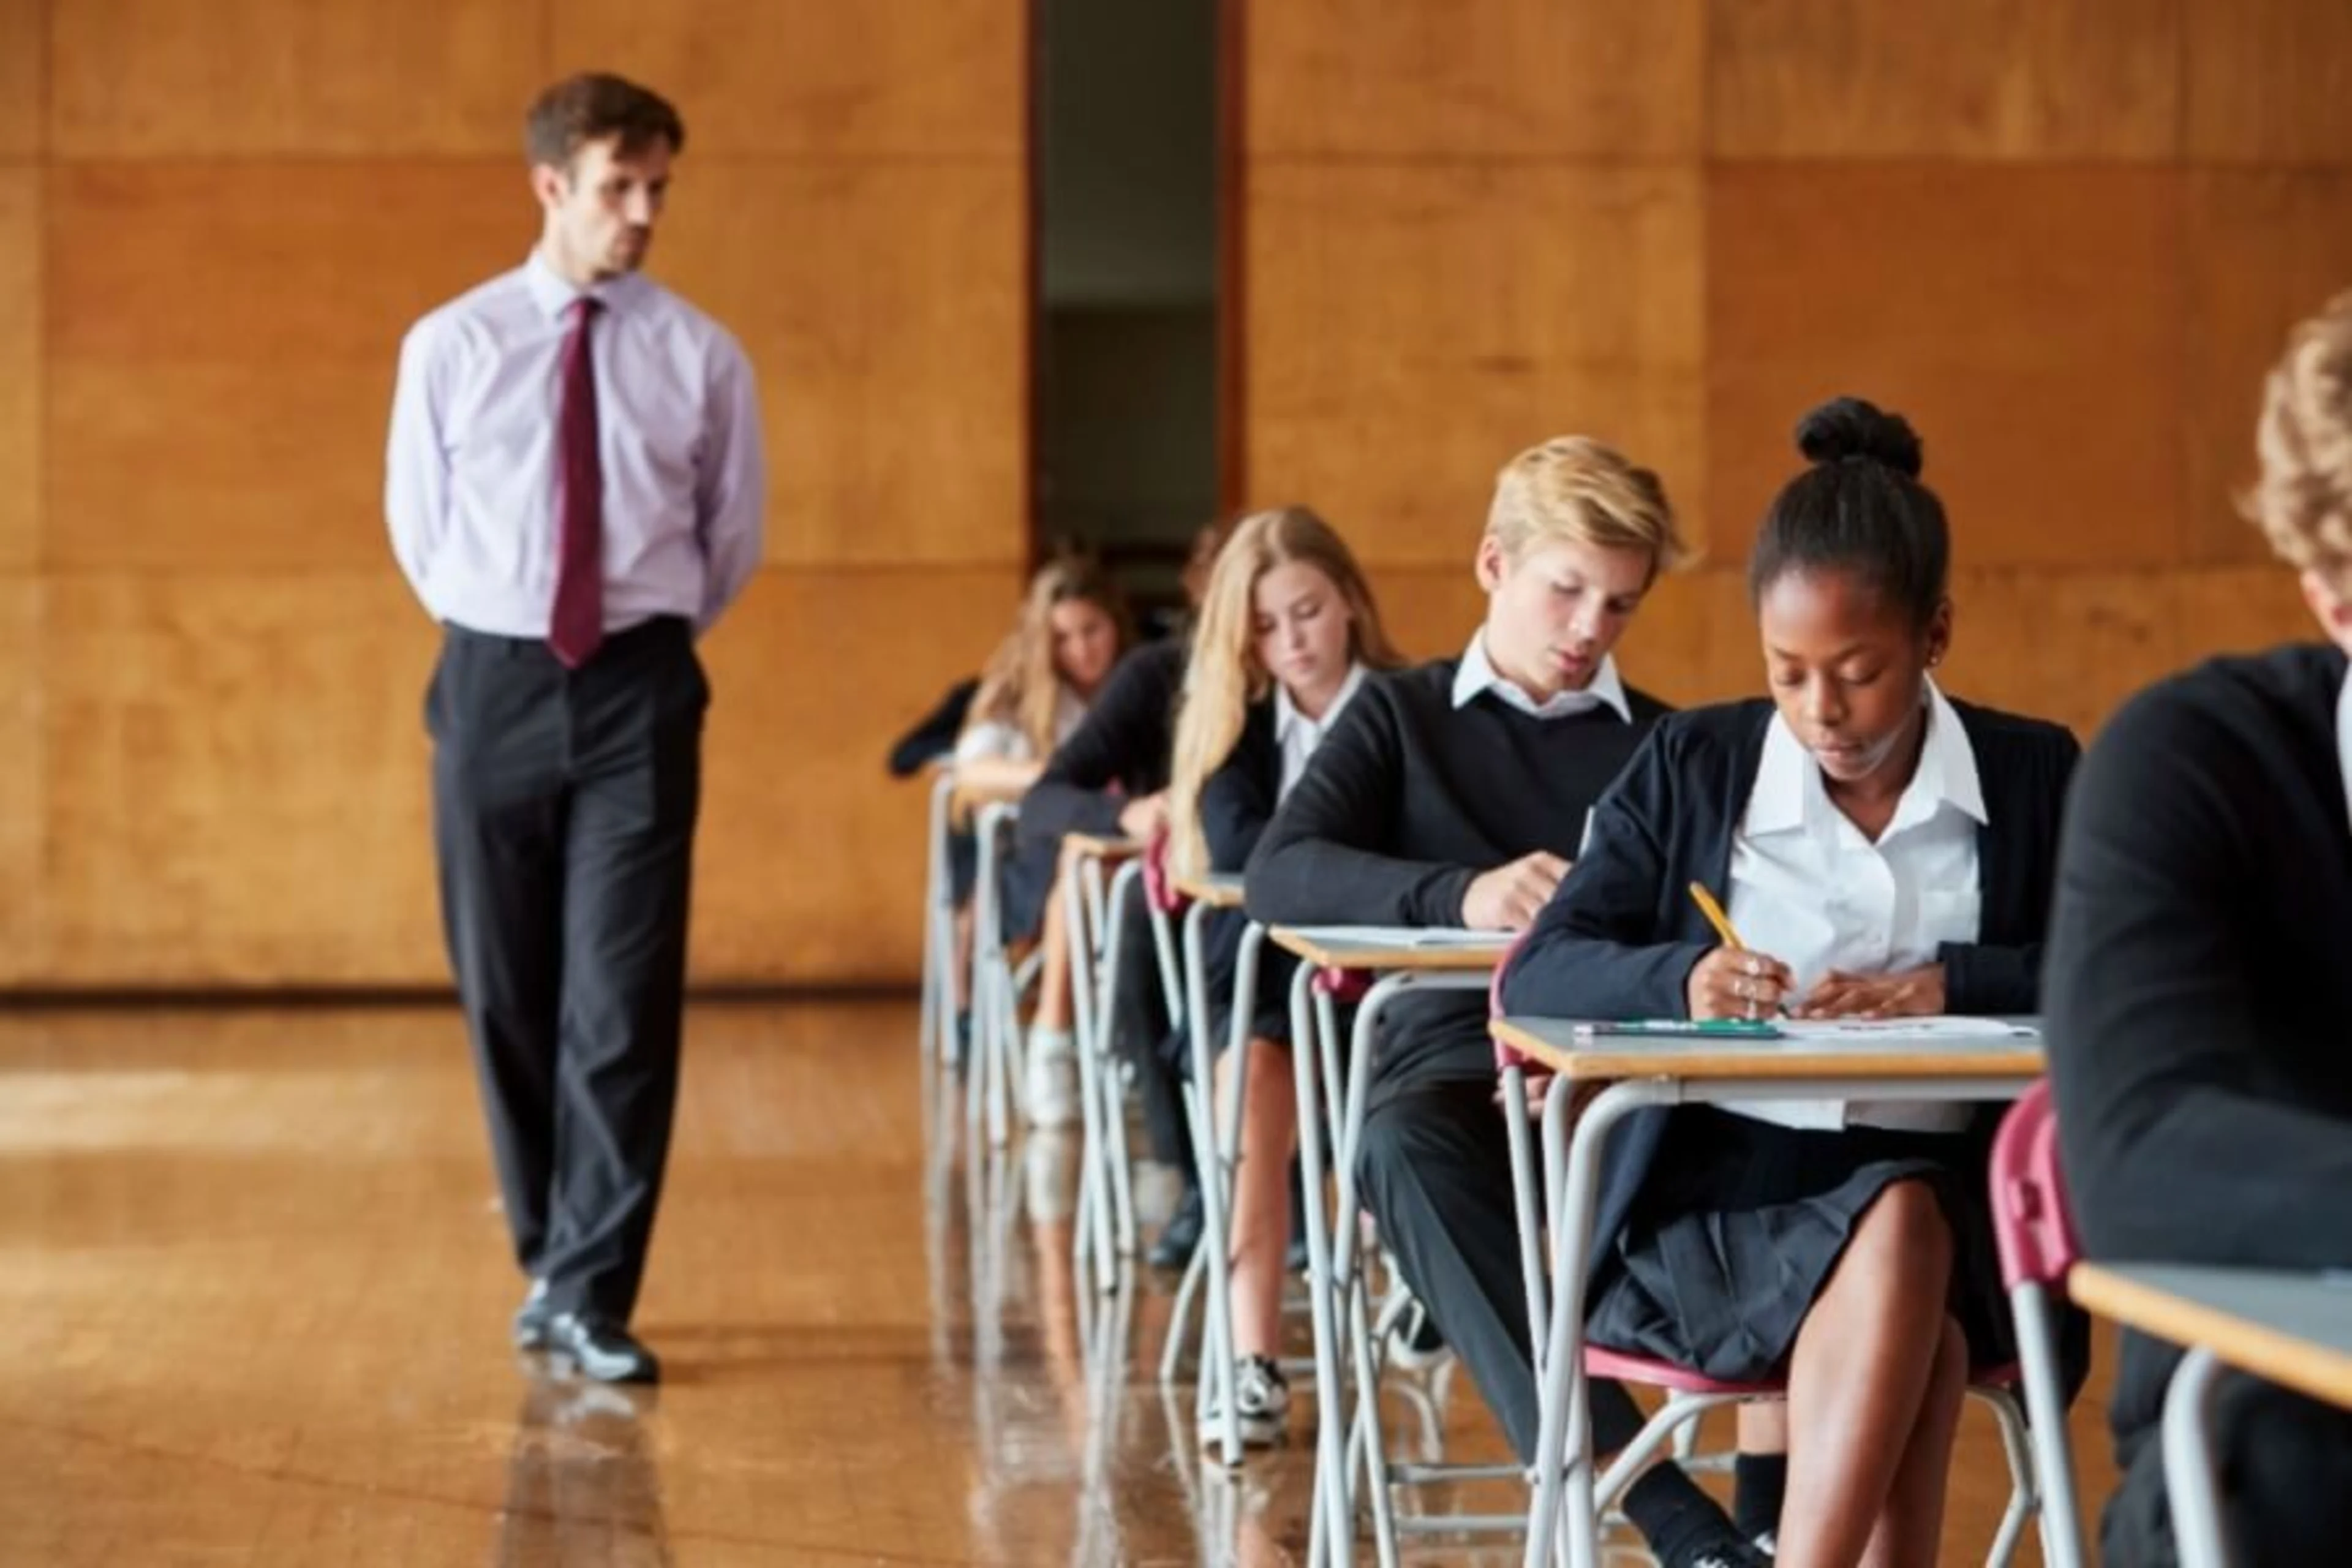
xmin=1503 ymin=698 xmax=2081 ymax=1274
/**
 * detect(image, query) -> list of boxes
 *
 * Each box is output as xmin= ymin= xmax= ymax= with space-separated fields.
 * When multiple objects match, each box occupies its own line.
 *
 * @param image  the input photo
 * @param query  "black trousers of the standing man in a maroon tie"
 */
xmin=426 ymin=618 xmax=710 ymax=1324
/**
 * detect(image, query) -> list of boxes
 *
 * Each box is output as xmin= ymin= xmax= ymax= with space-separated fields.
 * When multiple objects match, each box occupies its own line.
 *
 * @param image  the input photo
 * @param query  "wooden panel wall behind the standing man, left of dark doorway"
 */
xmin=0 ymin=0 xmax=1028 ymax=987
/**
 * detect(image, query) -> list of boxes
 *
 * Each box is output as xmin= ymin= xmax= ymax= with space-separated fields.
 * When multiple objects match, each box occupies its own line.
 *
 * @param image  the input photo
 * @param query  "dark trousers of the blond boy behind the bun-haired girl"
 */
xmin=1357 ymin=1079 xmax=1642 ymax=1460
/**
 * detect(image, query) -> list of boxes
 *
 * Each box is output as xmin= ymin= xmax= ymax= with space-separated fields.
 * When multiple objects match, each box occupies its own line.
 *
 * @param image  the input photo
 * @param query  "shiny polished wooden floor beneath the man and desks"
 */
xmin=0 ymin=1004 xmax=2108 ymax=1568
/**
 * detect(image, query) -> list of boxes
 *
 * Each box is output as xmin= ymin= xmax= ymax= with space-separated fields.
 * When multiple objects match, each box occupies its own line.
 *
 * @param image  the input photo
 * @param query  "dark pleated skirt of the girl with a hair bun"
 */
xmin=1585 ymin=1105 xmax=2016 ymax=1382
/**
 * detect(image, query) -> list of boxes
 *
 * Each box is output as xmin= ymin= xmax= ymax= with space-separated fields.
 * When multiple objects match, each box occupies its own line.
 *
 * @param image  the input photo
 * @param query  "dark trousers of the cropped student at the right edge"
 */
xmin=2100 ymin=1352 xmax=2352 ymax=1568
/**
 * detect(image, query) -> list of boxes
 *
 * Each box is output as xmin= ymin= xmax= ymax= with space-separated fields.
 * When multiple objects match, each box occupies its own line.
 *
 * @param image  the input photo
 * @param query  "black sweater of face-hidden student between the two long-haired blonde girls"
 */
xmin=1021 ymin=637 xmax=1185 ymax=853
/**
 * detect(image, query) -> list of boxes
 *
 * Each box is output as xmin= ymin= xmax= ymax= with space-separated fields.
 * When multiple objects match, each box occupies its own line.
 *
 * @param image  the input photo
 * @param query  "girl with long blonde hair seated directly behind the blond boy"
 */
xmin=1169 ymin=505 xmax=1402 ymax=1444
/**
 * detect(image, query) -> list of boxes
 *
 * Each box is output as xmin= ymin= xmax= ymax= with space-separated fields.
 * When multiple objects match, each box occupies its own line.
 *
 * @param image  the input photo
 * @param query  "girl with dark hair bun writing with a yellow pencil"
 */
xmin=1503 ymin=398 xmax=2077 ymax=1566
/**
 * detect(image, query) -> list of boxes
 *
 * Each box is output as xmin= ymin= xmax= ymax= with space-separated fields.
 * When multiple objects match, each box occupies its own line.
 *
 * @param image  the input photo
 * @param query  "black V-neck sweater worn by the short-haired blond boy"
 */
xmin=1246 ymin=658 xmax=1665 ymax=1088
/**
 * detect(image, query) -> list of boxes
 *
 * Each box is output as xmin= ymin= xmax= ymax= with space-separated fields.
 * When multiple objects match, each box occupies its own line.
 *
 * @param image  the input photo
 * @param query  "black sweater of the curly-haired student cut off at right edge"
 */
xmin=2044 ymin=646 xmax=2352 ymax=1464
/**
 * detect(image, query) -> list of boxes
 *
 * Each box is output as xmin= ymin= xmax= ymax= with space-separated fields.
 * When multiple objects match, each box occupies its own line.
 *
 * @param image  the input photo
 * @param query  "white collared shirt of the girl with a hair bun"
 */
xmin=1724 ymin=682 xmax=1988 ymax=1133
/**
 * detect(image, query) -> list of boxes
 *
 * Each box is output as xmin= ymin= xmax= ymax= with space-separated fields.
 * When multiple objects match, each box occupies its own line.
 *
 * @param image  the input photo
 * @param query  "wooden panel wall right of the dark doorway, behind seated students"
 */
xmin=1237 ymin=0 xmax=2352 ymax=747
